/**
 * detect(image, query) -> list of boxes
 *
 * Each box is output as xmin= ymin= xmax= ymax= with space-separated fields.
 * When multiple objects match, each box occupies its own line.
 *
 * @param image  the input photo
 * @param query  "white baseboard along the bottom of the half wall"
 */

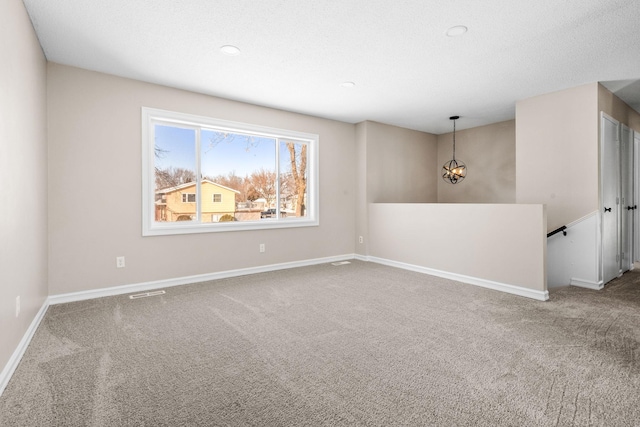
xmin=364 ymin=256 xmax=549 ymax=301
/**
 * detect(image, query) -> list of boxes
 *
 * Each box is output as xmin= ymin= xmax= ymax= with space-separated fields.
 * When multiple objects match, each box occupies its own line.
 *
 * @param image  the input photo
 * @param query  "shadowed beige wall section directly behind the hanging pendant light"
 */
xmin=436 ymin=120 xmax=516 ymax=203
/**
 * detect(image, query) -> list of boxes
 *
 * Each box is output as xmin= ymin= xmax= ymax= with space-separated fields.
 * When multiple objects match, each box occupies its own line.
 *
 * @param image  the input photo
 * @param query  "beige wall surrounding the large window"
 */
xmin=47 ymin=63 xmax=356 ymax=295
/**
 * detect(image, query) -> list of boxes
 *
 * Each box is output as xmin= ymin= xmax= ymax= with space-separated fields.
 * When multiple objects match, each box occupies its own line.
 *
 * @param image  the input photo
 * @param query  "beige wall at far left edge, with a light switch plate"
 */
xmin=0 ymin=0 xmax=47 ymax=380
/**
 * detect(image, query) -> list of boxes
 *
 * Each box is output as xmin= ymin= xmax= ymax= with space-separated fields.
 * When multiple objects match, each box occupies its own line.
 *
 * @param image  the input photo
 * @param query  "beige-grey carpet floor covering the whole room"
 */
xmin=0 ymin=261 xmax=640 ymax=426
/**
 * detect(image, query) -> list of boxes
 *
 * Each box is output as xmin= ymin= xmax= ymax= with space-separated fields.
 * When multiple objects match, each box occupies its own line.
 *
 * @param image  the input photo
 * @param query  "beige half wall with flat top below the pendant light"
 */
xmin=369 ymin=203 xmax=547 ymax=296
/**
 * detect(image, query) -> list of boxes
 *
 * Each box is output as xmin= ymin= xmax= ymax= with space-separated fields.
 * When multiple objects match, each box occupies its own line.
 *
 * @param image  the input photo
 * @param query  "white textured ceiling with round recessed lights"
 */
xmin=24 ymin=0 xmax=640 ymax=134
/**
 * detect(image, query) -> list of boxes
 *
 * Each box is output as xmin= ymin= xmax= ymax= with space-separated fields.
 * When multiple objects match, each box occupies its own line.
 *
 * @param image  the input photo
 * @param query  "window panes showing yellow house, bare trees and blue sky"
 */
xmin=142 ymin=107 xmax=313 ymax=234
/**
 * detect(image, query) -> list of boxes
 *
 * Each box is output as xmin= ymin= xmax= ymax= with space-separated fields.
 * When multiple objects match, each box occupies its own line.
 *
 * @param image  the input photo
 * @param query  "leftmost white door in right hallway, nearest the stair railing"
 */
xmin=600 ymin=114 xmax=620 ymax=283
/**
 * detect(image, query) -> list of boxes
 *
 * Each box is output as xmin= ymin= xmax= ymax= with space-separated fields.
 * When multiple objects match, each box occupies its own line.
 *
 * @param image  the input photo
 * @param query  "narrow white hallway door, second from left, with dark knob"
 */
xmin=620 ymin=124 xmax=635 ymax=272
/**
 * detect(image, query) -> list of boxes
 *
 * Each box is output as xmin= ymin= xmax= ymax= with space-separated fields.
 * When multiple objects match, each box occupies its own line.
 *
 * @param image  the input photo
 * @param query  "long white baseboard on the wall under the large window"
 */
xmin=48 ymin=254 xmax=355 ymax=305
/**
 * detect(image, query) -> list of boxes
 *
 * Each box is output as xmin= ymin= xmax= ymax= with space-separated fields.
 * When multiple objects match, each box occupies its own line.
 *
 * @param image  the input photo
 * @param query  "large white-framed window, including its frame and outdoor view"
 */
xmin=142 ymin=108 xmax=318 ymax=235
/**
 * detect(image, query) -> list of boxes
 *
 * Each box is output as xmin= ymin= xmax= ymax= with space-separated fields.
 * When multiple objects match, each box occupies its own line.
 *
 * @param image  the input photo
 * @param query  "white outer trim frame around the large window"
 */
xmin=142 ymin=107 xmax=320 ymax=236
